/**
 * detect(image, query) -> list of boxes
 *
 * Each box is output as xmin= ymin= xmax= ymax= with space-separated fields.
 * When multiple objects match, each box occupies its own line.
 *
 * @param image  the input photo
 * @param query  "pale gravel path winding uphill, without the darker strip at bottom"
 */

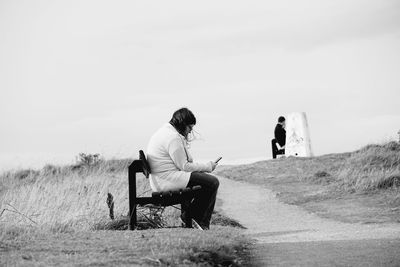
xmin=218 ymin=176 xmax=400 ymax=244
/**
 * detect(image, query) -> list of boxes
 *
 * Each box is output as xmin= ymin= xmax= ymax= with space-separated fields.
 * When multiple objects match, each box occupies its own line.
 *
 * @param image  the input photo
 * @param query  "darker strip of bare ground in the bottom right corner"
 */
xmin=248 ymin=239 xmax=400 ymax=267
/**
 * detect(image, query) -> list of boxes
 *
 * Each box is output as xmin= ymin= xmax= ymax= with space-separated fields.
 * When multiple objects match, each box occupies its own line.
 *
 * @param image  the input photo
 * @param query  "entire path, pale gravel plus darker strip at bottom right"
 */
xmin=218 ymin=177 xmax=400 ymax=266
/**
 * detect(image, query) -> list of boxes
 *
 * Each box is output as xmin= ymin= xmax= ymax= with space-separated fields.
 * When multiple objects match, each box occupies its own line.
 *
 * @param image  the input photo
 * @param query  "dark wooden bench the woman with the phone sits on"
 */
xmin=128 ymin=150 xmax=201 ymax=230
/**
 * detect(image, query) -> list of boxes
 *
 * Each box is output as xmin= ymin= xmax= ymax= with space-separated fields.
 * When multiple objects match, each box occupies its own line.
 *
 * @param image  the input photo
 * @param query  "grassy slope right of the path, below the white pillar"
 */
xmin=216 ymin=142 xmax=400 ymax=223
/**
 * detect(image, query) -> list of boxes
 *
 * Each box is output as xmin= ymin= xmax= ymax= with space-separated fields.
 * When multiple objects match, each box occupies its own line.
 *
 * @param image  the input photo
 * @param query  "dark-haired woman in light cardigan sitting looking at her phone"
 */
xmin=147 ymin=108 xmax=219 ymax=229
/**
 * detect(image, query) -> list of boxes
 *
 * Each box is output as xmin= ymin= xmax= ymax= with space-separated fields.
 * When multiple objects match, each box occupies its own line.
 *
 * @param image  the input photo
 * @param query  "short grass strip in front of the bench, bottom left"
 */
xmin=0 ymin=226 xmax=250 ymax=266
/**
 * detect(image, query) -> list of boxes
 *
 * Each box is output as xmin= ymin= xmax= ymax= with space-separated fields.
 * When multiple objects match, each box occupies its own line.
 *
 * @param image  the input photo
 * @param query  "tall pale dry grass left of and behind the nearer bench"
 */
xmin=0 ymin=160 xmax=150 ymax=230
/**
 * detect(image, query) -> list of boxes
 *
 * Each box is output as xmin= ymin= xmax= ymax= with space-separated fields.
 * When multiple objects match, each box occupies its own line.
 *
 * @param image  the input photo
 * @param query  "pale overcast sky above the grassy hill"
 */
xmin=0 ymin=0 xmax=400 ymax=169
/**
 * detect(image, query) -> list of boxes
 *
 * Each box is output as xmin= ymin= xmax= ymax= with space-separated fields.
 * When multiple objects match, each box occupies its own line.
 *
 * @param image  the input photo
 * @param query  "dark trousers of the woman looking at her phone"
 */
xmin=181 ymin=172 xmax=219 ymax=229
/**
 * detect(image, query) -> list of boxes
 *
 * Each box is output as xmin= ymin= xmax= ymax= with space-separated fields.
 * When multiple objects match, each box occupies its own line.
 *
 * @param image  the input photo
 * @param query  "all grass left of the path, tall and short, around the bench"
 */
xmin=0 ymin=157 xmax=249 ymax=266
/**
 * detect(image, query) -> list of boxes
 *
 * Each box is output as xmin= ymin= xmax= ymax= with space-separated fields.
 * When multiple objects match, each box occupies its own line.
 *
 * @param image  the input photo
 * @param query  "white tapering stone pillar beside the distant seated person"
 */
xmin=285 ymin=112 xmax=313 ymax=157
